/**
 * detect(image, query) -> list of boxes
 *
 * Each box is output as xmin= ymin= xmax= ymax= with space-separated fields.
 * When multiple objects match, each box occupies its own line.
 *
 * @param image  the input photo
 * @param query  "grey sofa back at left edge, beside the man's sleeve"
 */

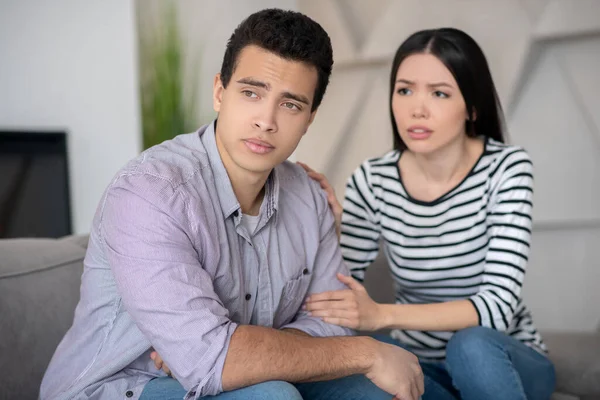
xmin=0 ymin=236 xmax=87 ymax=399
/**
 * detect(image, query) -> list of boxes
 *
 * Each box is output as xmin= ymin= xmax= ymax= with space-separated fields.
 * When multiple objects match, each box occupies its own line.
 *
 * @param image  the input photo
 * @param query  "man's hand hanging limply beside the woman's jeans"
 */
xmin=366 ymin=342 xmax=425 ymax=400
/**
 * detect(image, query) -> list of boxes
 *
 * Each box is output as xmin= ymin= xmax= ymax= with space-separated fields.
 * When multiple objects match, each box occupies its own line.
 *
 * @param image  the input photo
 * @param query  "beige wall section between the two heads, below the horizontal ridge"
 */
xmin=295 ymin=67 xmax=392 ymax=194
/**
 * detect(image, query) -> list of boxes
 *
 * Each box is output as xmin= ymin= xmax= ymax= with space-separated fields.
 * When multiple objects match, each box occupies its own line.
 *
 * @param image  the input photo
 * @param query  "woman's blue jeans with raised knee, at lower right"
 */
xmin=375 ymin=327 xmax=555 ymax=400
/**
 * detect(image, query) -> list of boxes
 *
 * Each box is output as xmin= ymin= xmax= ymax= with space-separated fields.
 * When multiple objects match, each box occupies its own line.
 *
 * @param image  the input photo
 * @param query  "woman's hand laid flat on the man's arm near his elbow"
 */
xmin=304 ymin=274 xmax=385 ymax=331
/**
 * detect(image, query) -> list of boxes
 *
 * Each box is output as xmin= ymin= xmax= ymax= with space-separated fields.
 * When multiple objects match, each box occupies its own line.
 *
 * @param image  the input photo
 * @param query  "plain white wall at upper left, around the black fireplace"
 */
xmin=0 ymin=0 xmax=141 ymax=233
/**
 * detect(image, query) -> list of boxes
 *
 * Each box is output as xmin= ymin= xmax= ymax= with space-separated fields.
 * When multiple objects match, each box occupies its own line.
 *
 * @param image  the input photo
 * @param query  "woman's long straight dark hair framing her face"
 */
xmin=390 ymin=28 xmax=504 ymax=150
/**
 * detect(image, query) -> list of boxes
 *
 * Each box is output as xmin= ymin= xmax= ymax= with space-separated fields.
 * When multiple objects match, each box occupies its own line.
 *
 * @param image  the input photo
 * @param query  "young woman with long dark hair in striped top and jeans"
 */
xmin=305 ymin=28 xmax=555 ymax=400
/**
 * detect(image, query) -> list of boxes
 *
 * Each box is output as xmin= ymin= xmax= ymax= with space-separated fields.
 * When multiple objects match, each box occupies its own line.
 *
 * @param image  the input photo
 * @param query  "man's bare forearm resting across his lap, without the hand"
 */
xmin=222 ymin=325 xmax=375 ymax=391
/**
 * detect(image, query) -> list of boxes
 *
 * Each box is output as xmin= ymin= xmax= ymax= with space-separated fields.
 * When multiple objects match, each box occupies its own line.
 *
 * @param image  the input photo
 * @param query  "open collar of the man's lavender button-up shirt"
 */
xmin=199 ymin=120 xmax=279 ymax=220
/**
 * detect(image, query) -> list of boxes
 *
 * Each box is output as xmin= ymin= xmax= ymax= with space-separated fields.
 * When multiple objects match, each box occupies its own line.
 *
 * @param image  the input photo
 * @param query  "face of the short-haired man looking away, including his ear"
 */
xmin=213 ymin=46 xmax=318 ymax=180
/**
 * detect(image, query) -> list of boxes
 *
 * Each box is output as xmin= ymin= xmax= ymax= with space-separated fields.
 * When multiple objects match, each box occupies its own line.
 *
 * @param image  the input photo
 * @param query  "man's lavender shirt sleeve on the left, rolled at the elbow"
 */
xmin=99 ymin=175 xmax=237 ymax=398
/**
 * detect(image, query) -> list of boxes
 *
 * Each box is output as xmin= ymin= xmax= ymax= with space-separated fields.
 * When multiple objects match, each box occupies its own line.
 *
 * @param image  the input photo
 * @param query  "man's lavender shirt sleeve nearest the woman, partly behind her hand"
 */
xmin=282 ymin=181 xmax=355 ymax=337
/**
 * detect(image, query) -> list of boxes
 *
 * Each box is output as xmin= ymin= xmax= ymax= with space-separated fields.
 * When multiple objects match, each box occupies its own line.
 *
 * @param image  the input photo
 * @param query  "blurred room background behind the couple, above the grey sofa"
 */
xmin=0 ymin=0 xmax=600 ymax=331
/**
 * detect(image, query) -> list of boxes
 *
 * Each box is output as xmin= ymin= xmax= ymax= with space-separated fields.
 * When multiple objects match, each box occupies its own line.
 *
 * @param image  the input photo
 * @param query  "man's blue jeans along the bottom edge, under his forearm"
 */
xmin=140 ymin=375 xmax=392 ymax=400
